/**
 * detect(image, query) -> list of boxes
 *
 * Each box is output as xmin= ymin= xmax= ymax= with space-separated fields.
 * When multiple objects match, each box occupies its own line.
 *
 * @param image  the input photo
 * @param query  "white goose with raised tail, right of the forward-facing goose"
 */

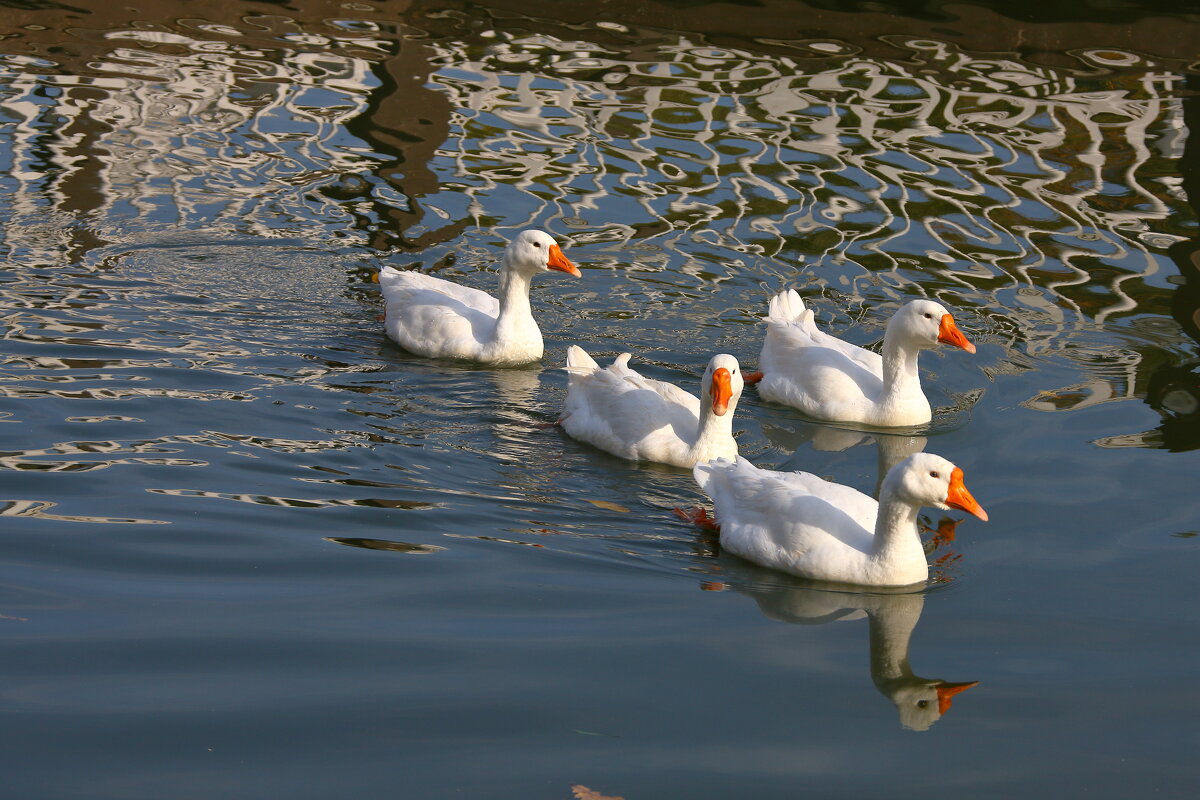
xmin=746 ymin=289 xmax=976 ymax=427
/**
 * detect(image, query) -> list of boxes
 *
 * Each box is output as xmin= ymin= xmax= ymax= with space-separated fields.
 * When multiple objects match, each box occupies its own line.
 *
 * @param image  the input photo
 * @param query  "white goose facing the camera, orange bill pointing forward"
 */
xmin=558 ymin=344 xmax=743 ymax=468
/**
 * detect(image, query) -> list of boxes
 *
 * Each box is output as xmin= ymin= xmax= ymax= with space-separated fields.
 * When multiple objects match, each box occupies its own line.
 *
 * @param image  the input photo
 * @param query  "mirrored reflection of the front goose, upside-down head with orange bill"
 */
xmin=703 ymin=568 xmax=979 ymax=730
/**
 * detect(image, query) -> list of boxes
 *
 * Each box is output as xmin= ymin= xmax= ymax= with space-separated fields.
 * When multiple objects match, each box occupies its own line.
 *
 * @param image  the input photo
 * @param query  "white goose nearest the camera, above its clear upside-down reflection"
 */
xmin=692 ymin=452 xmax=988 ymax=587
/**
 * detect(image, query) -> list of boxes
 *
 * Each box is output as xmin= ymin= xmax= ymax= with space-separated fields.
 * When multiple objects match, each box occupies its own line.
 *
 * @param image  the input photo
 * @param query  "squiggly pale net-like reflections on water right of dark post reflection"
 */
xmin=420 ymin=36 xmax=1180 ymax=326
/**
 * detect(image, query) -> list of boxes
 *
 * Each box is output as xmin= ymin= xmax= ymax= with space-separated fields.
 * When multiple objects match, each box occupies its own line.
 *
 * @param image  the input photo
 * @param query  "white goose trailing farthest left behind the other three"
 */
xmin=379 ymin=230 xmax=580 ymax=365
